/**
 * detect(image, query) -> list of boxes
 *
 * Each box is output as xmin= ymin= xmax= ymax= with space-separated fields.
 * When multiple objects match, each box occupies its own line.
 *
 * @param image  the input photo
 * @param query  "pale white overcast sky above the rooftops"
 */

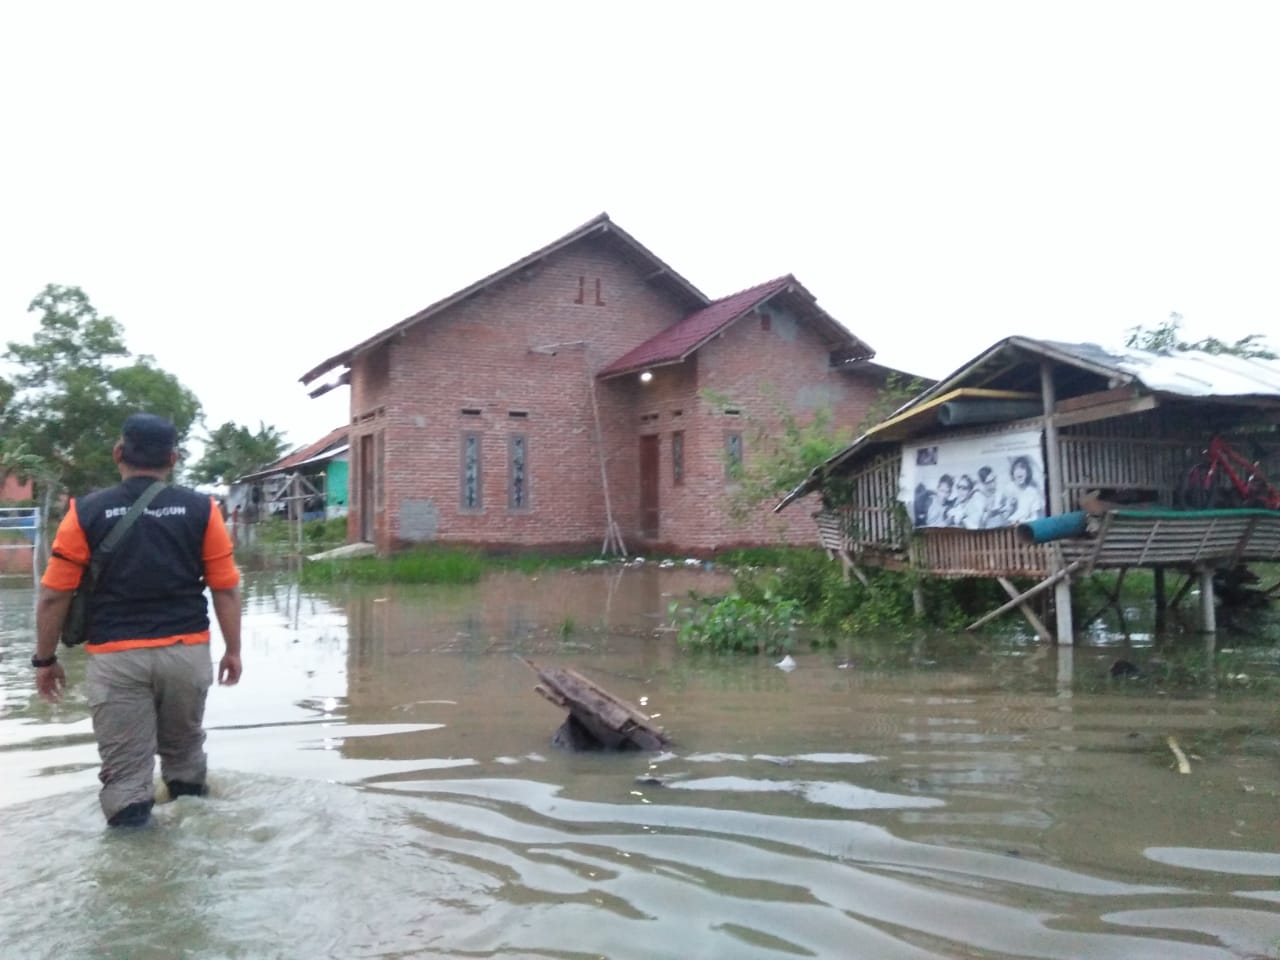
xmin=0 ymin=0 xmax=1280 ymax=455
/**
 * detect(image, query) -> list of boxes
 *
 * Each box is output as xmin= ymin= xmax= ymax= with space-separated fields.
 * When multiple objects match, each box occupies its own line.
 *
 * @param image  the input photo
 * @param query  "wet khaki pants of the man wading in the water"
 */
xmin=88 ymin=644 xmax=214 ymax=819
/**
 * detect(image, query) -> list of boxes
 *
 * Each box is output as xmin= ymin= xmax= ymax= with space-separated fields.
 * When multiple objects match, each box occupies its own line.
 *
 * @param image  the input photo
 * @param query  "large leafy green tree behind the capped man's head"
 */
xmin=0 ymin=284 xmax=200 ymax=494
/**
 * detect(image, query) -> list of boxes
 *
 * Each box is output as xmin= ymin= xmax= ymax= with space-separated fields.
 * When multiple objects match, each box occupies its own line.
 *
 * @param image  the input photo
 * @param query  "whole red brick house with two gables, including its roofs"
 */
xmin=301 ymin=214 xmax=916 ymax=553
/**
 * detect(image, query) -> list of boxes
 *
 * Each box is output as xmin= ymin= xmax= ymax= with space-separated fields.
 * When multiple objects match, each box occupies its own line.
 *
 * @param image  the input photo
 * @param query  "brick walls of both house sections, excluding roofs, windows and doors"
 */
xmin=348 ymin=241 xmax=896 ymax=552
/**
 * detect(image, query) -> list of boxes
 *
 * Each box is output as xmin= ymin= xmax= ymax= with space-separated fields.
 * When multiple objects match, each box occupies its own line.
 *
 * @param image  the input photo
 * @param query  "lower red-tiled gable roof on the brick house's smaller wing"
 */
xmin=598 ymin=274 xmax=876 ymax=380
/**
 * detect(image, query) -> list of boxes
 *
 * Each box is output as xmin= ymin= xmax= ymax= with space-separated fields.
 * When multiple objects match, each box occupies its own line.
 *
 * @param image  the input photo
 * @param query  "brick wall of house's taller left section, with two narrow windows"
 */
xmin=349 ymin=241 xmax=685 ymax=549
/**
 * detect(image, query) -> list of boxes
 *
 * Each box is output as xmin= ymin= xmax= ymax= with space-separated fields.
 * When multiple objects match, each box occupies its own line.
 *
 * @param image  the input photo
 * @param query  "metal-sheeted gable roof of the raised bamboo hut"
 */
xmin=774 ymin=337 xmax=1280 ymax=512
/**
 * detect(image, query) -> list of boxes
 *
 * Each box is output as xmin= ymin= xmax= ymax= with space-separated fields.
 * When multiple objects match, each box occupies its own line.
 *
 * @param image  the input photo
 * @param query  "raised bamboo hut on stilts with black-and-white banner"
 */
xmin=777 ymin=337 xmax=1280 ymax=643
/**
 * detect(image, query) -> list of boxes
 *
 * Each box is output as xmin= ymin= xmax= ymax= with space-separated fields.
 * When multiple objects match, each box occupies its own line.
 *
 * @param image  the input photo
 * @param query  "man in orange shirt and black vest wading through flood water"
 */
xmin=31 ymin=413 xmax=241 ymax=827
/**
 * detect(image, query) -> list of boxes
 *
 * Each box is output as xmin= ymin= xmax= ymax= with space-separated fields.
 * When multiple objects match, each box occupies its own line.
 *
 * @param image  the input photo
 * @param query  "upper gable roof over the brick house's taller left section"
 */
xmin=298 ymin=214 xmax=708 ymax=386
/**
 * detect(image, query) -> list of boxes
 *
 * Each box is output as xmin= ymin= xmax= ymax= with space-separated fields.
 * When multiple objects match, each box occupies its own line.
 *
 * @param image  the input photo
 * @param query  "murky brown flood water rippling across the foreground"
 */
xmin=0 ymin=564 xmax=1280 ymax=960
